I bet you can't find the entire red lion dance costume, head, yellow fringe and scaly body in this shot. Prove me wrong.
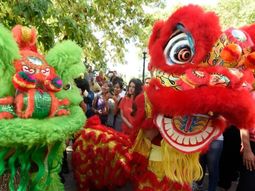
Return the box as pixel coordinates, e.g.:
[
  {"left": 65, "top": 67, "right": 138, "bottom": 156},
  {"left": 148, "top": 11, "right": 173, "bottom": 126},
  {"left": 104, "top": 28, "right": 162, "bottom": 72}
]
[{"left": 73, "top": 5, "right": 255, "bottom": 191}]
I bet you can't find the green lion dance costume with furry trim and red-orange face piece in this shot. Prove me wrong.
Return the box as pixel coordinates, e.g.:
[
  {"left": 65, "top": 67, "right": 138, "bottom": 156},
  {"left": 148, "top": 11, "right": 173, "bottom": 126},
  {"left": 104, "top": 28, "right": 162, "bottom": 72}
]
[{"left": 0, "top": 25, "right": 85, "bottom": 191}]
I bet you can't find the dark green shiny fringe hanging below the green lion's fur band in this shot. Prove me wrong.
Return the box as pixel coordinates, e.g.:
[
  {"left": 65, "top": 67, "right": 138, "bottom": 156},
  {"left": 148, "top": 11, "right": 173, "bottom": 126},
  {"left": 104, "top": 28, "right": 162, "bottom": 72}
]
[{"left": 0, "top": 142, "right": 64, "bottom": 191}]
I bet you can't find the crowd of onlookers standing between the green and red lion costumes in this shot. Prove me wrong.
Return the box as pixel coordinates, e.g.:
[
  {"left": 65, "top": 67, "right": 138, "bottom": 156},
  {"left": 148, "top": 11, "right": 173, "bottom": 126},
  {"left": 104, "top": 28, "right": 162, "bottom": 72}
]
[{"left": 76, "top": 66, "right": 147, "bottom": 135}]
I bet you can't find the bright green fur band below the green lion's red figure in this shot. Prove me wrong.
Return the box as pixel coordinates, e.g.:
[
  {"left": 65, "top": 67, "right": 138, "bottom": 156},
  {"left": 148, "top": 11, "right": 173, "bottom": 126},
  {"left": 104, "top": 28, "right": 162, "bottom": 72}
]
[{"left": 0, "top": 106, "right": 86, "bottom": 147}]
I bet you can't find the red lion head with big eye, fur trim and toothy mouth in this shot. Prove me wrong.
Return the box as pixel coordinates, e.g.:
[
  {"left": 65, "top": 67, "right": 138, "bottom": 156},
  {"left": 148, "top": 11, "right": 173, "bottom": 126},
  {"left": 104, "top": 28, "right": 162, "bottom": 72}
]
[{"left": 145, "top": 5, "right": 255, "bottom": 153}]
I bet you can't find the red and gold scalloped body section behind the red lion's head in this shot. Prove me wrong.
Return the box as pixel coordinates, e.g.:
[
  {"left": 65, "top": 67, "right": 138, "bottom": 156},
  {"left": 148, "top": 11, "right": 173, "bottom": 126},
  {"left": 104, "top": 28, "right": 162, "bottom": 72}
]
[{"left": 72, "top": 121, "right": 131, "bottom": 190}]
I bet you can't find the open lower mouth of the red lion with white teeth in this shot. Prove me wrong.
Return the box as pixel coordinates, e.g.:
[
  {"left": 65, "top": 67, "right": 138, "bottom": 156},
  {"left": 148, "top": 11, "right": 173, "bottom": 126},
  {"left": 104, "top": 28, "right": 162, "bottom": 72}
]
[{"left": 155, "top": 115, "right": 221, "bottom": 153}]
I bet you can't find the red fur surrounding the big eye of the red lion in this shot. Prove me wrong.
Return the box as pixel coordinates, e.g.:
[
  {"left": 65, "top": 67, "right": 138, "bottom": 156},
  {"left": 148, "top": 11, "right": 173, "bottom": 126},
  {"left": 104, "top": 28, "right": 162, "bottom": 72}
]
[{"left": 149, "top": 5, "right": 222, "bottom": 73}]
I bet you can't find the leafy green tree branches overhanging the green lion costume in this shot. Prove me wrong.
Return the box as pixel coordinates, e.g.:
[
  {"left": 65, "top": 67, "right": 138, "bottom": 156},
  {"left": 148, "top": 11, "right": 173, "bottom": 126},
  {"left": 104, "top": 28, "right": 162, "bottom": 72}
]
[{"left": 0, "top": 0, "right": 159, "bottom": 67}]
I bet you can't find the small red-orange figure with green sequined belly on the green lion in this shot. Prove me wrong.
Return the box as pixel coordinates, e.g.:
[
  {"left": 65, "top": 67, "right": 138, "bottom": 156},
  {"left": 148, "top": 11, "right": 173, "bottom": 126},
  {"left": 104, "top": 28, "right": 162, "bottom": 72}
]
[{"left": 0, "top": 25, "right": 69, "bottom": 119}]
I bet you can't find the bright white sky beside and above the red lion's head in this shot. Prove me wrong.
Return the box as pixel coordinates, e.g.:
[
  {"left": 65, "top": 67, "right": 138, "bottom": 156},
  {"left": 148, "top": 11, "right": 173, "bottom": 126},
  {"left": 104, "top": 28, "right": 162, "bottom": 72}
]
[{"left": 108, "top": 0, "right": 219, "bottom": 82}]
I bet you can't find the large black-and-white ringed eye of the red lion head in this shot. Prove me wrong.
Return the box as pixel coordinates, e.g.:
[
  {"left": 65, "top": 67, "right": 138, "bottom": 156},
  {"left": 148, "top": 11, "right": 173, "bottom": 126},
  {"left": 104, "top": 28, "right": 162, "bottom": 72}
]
[{"left": 164, "top": 31, "right": 194, "bottom": 65}]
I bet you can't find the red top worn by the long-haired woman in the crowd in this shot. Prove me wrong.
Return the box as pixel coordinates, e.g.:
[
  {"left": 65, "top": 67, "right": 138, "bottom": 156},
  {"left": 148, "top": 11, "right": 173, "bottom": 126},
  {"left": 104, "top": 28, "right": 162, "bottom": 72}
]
[{"left": 119, "top": 96, "right": 135, "bottom": 135}]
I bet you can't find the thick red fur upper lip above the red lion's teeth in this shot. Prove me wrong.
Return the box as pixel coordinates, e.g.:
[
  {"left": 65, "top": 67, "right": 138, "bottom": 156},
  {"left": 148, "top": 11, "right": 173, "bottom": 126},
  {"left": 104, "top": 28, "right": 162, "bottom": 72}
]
[{"left": 146, "top": 79, "right": 255, "bottom": 128}]
